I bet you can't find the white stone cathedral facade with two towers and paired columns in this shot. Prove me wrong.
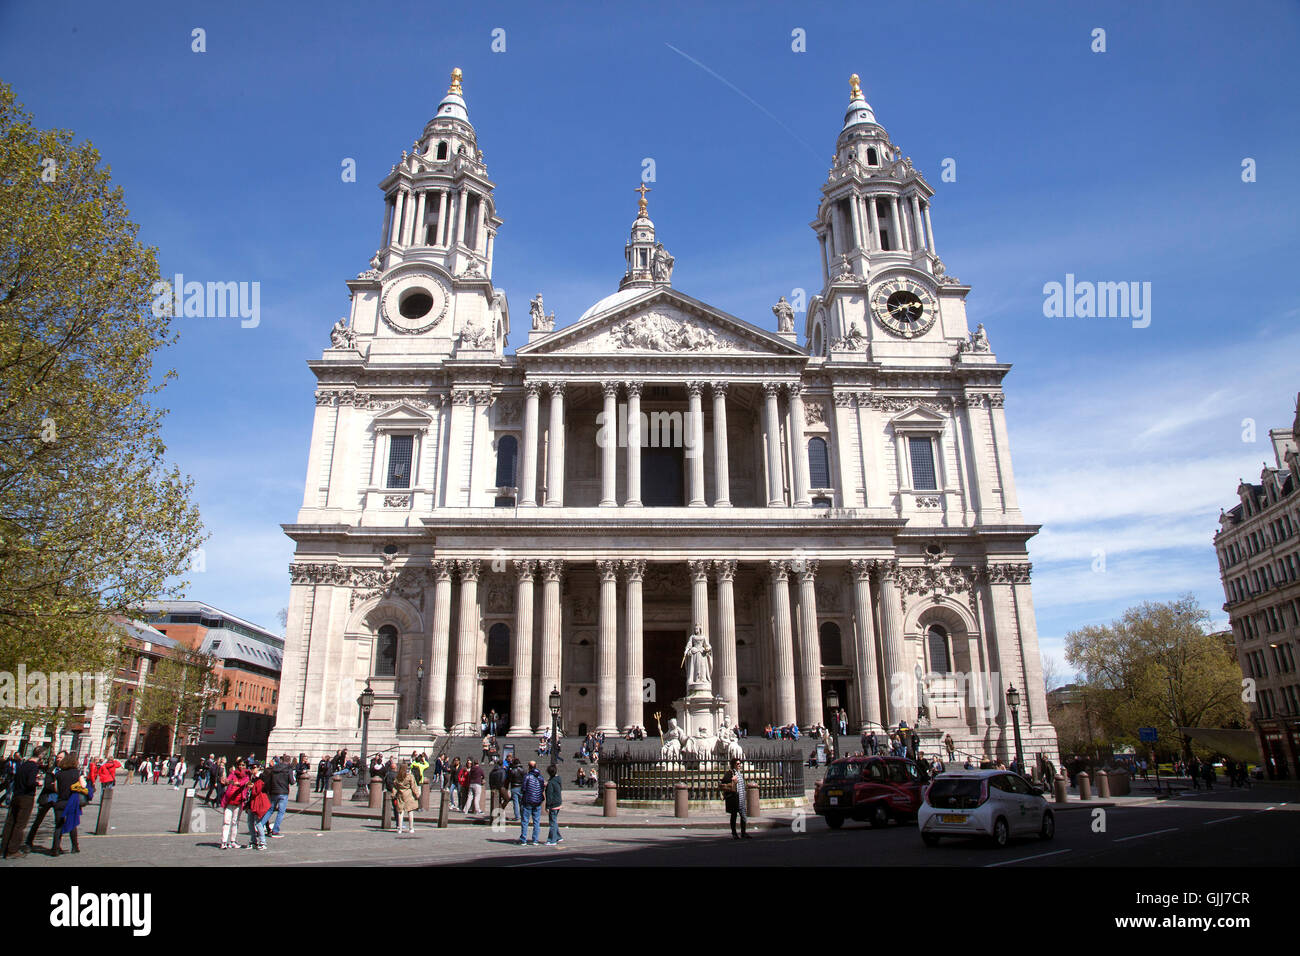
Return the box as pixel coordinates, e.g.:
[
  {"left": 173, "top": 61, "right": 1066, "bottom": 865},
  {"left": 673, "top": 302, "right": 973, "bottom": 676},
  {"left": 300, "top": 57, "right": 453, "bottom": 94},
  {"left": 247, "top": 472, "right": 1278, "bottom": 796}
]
[{"left": 270, "top": 70, "right": 1057, "bottom": 760}]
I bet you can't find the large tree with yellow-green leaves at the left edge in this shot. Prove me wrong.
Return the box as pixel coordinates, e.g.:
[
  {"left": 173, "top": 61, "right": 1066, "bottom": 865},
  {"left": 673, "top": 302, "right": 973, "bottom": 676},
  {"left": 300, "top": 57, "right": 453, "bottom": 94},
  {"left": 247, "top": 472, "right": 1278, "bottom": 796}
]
[{"left": 0, "top": 83, "right": 203, "bottom": 726}]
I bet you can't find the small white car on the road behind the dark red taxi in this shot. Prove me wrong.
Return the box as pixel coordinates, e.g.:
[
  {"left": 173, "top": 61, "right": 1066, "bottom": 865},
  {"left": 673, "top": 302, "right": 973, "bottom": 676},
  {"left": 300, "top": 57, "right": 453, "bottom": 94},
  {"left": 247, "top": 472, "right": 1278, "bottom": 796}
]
[{"left": 917, "top": 770, "right": 1056, "bottom": 847}]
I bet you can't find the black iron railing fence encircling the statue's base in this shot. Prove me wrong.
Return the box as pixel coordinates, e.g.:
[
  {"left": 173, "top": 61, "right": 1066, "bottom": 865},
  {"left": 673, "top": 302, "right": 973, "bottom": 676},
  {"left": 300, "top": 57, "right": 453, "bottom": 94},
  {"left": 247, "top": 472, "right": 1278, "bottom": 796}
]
[{"left": 599, "top": 749, "right": 805, "bottom": 801}]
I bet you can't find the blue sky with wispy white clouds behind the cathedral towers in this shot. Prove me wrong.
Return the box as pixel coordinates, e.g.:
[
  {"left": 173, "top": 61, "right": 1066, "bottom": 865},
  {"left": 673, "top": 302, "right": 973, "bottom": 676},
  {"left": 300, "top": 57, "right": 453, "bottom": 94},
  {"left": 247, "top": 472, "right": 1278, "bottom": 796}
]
[{"left": 0, "top": 0, "right": 1300, "bottom": 676}]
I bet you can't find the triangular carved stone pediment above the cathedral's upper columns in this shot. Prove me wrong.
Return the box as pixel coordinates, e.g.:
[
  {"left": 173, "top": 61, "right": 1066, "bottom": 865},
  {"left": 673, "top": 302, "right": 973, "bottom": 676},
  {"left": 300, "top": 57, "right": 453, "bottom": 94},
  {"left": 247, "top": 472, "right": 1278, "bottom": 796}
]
[{"left": 516, "top": 287, "right": 807, "bottom": 356}]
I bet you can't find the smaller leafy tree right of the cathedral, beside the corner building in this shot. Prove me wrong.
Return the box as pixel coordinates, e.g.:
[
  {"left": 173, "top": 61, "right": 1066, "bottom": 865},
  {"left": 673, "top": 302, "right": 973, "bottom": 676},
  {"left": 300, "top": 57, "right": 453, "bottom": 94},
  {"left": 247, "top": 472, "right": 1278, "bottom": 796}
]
[{"left": 1065, "top": 594, "right": 1249, "bottom": 757}]
